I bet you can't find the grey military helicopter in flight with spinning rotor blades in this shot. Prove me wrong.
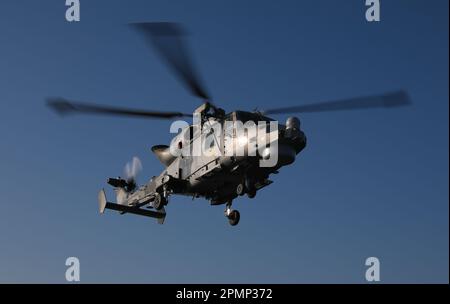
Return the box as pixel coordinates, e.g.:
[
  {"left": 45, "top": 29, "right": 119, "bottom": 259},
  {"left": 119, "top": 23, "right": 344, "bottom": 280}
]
[{"left": 47, "top": 22, "right": 410, "bottom": 226}]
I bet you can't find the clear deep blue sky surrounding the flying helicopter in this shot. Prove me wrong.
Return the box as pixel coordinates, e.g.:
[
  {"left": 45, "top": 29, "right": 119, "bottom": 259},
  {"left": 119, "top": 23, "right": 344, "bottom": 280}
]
[{"left": 0, "top": 0, "right": 449, "bottom": 283}]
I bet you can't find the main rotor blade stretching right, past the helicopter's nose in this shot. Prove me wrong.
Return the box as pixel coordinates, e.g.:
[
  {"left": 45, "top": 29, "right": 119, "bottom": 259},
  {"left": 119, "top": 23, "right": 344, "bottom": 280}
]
[{"left": 262, "top": 91, "right": 411, "bottom": 114}]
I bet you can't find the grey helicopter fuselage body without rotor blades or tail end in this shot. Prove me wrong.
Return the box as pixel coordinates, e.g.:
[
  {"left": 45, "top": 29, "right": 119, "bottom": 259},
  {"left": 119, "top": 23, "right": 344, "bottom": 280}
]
[{"left": 137, "top": 107, "right": 306, "bottom": 205}]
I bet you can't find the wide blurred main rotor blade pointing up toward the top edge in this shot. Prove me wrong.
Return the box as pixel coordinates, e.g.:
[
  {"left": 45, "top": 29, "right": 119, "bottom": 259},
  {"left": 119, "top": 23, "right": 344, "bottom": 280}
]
[{"left": 130, "top": 22, "right": 211, "bottom": 100}]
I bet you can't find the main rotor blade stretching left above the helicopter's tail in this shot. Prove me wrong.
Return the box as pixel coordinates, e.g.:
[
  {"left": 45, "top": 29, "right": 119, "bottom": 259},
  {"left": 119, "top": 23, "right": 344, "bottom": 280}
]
[{"left": 47, "top": 97, "right": 191, "bottom": 119}]
